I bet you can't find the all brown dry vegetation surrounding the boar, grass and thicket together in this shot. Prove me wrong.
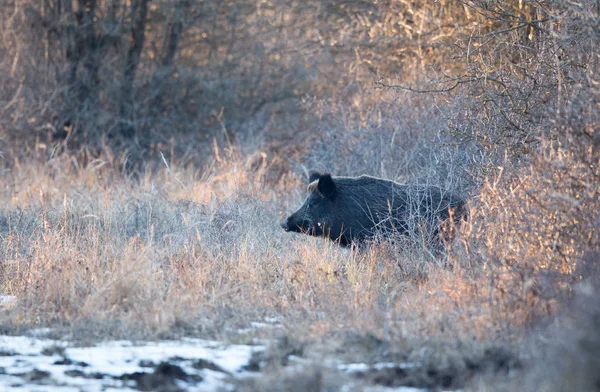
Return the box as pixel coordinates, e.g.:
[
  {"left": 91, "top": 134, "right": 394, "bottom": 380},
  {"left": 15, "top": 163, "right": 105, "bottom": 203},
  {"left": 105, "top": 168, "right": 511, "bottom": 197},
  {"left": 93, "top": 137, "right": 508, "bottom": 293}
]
[{"left": 0, "top": 0, "right": 600, "bottom": 390}]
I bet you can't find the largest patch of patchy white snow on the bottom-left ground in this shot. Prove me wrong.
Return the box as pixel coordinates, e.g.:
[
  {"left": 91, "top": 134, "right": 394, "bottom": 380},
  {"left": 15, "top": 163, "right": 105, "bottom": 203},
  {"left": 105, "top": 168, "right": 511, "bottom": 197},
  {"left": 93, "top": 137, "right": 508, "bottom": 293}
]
[{"left": 0, "top": 335, "right": 264, "bottom": 391}]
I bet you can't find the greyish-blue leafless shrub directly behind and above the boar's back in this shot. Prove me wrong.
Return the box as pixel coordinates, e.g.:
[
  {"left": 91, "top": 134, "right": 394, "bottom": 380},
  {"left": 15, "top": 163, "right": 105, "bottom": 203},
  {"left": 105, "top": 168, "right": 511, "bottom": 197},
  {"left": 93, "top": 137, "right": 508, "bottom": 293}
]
[{"left": 301, "top": 95, "right": 474, "bottom": 194}]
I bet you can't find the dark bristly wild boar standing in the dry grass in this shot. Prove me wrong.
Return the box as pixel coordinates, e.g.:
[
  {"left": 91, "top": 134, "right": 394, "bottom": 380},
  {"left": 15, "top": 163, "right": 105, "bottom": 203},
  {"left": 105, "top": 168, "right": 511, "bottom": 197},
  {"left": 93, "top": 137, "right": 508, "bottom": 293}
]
[{"left": 281, "top": 173, "right": 466, "bottom": 246}]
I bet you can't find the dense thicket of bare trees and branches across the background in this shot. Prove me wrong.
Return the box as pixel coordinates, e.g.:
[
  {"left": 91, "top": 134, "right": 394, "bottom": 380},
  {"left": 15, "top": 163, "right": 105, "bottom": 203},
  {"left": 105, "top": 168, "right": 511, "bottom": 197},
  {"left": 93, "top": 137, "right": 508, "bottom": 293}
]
[{"left": 0, "top": 0, "right": 598, "bottom": 155}]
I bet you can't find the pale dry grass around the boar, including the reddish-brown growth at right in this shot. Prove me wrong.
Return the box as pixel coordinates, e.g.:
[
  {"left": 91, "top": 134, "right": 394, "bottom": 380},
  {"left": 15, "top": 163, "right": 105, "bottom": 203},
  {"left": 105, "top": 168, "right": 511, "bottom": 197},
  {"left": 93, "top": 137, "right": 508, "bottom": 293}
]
[{"left": 0, "top": 121, "right": 598, "bottom": 389}]
